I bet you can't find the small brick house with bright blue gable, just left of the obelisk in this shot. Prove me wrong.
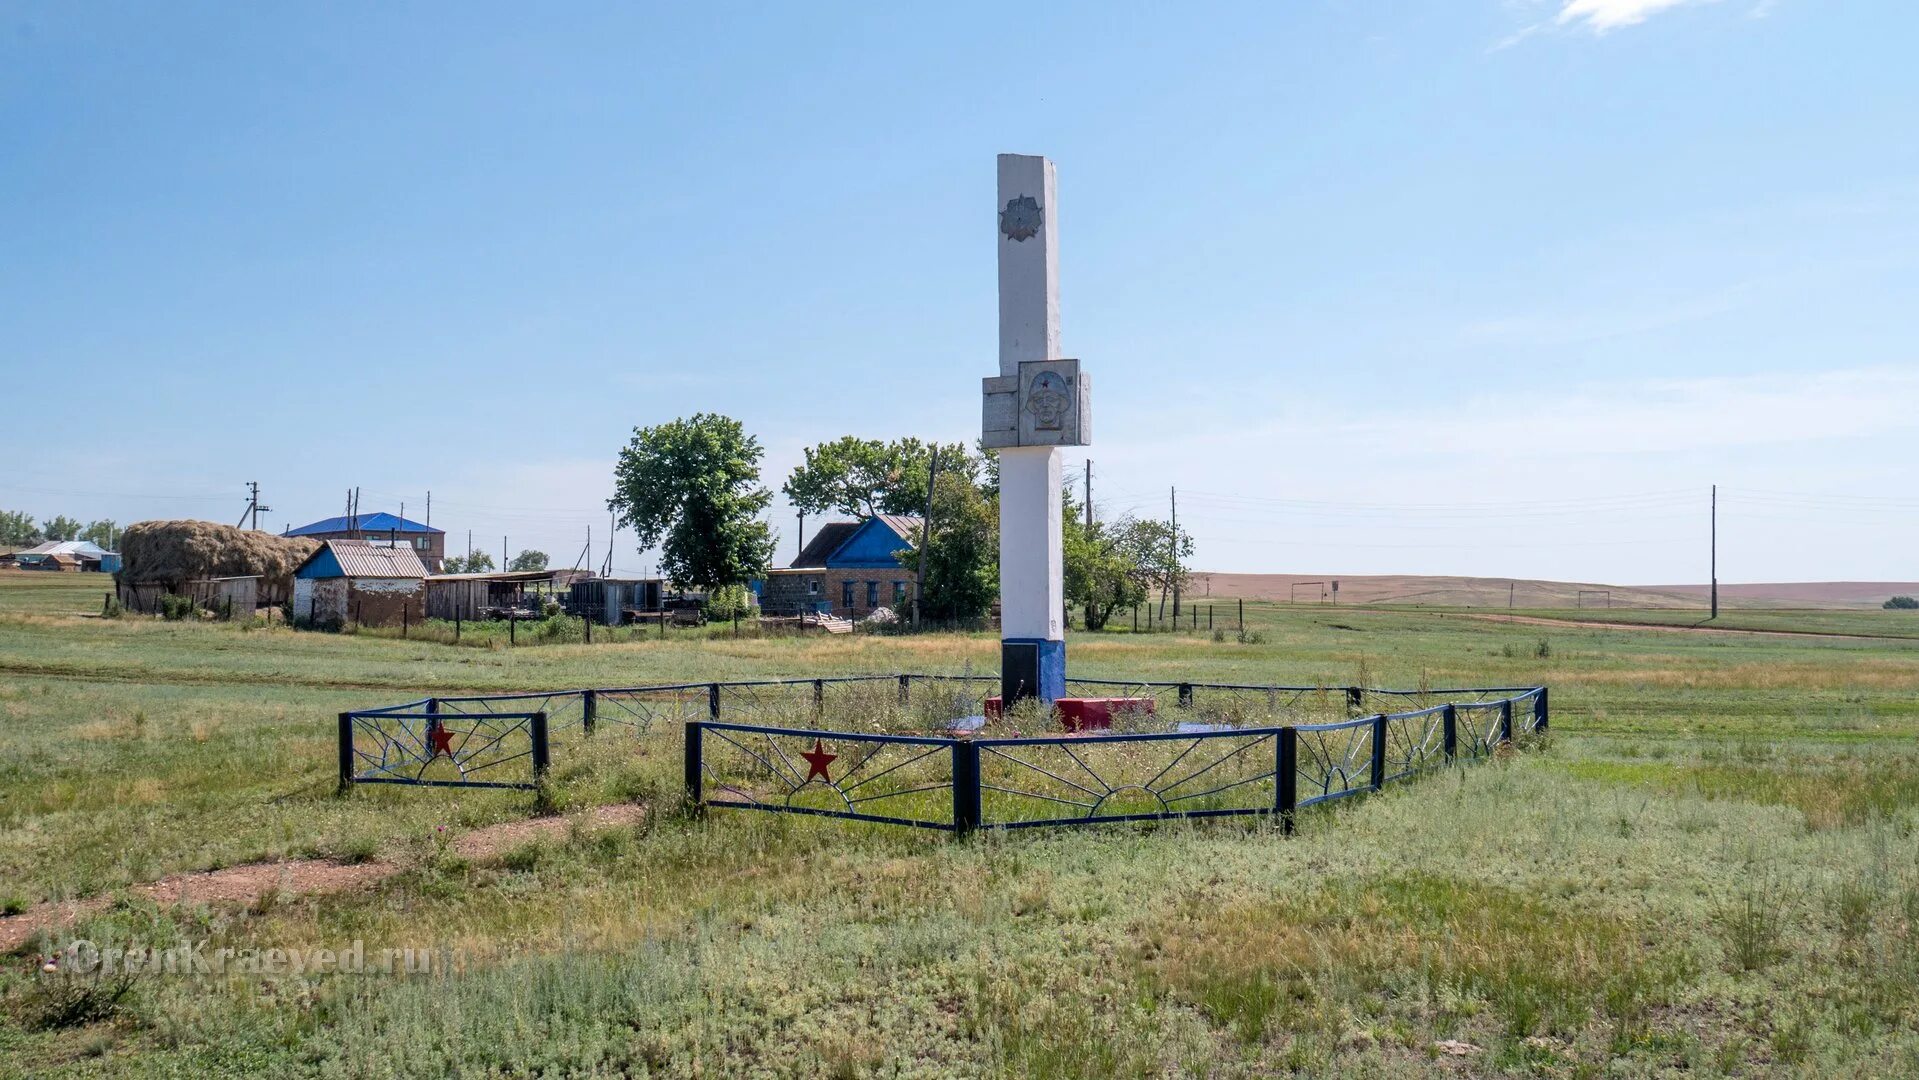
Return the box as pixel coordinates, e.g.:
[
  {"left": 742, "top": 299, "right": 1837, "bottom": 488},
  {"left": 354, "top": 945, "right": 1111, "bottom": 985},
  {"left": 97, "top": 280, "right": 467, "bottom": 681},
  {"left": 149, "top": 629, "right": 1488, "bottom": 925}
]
[{"left": 754, "top": 514, "right": 919, "bottom": 620}]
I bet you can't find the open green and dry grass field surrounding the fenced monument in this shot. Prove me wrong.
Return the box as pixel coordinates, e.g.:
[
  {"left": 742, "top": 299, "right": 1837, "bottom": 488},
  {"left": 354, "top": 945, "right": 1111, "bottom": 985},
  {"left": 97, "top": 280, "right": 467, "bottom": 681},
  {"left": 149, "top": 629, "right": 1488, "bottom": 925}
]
[{"left": 0, "top": 574, "right": 1919, "bottom": 1076}]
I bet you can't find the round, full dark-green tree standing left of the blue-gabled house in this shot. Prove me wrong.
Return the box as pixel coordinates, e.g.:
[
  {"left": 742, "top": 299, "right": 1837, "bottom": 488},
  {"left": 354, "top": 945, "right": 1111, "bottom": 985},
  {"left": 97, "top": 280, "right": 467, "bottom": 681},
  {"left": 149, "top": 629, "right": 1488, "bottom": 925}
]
[{"left": 606, "top": 412, "right": 773, "bottom": 589}]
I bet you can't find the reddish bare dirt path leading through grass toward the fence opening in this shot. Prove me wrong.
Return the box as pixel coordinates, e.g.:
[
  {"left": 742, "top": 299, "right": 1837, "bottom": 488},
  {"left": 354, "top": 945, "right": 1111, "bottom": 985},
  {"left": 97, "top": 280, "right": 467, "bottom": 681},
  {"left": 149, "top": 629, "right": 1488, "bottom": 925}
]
[{"left": 0, "top": 804, "right": 647, "bottom": 955}]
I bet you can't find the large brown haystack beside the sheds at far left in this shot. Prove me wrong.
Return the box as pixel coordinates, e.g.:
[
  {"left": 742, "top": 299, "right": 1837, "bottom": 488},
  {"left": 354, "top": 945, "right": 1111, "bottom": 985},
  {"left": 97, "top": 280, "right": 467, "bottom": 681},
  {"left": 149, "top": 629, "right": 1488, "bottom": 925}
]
[{"left": 119, "top": 522, "right": 320, "bottom": 597}]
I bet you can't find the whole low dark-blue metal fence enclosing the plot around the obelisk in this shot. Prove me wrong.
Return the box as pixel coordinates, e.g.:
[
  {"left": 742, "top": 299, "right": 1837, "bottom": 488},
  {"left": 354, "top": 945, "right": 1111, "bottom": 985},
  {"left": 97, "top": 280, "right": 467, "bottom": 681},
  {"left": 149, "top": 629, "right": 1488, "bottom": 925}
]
[{"left": 340, "top": 673, "right": 1549, "bottom": 833}]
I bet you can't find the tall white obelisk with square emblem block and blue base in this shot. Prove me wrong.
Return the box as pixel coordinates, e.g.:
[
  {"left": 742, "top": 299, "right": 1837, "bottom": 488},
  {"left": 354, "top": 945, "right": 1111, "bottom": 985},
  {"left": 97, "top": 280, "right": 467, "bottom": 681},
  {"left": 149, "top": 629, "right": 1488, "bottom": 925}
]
[{"left": 983, "top": 153, "right": 1092, "bottom": 704}]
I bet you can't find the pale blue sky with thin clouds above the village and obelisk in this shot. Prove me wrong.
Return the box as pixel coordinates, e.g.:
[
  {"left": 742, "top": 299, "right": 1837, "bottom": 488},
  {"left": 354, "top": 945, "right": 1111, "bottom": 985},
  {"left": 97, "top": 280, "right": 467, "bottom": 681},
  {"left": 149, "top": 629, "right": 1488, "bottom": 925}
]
[{"left": 0, "top": 0, "right": 1919, "bottom": 583}]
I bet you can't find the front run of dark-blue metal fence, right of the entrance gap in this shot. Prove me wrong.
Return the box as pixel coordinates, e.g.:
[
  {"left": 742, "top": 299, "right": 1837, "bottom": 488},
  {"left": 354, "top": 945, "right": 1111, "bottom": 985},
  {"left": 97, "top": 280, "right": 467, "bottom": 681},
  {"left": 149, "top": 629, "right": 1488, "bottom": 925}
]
[{"left": 683, "top": 683, "right": 1549, "bottom": 833}]
